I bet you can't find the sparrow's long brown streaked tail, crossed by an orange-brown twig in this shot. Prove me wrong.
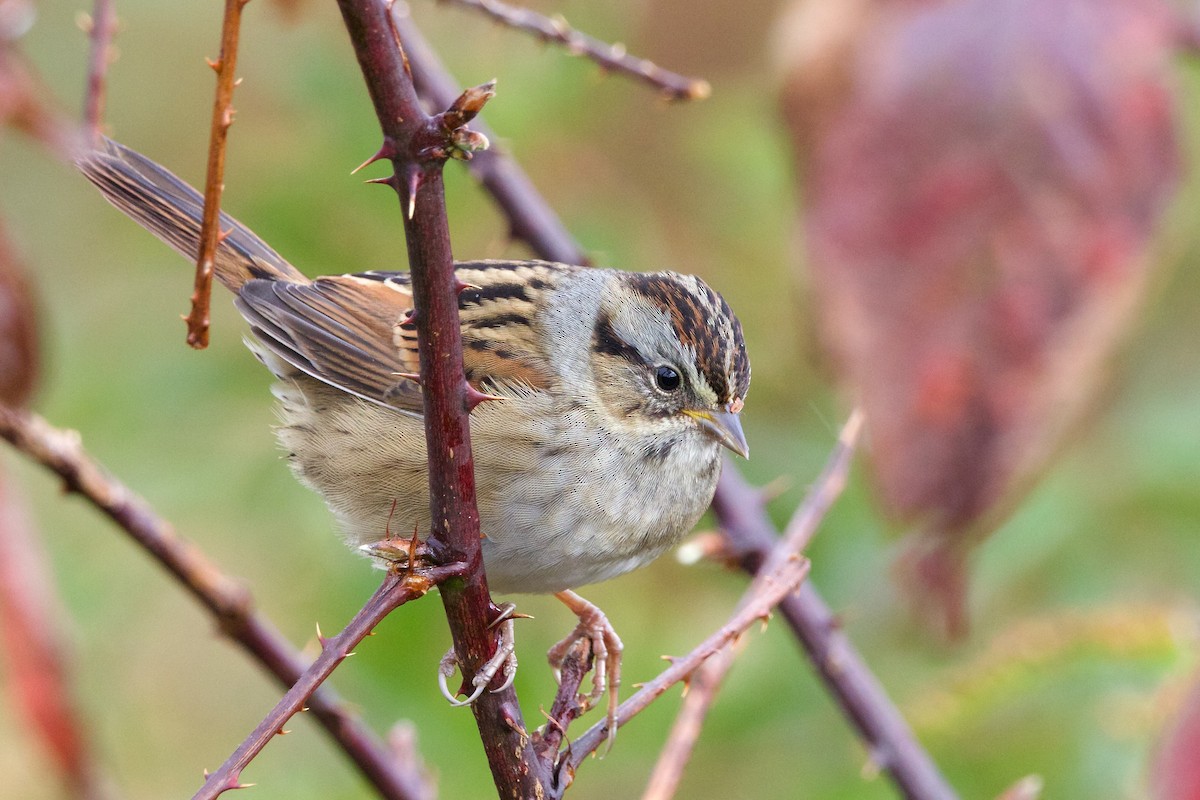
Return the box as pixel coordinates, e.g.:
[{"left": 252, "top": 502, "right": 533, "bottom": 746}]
[{"left": 76, "top": 139, "right": 308, "bottom": 291}]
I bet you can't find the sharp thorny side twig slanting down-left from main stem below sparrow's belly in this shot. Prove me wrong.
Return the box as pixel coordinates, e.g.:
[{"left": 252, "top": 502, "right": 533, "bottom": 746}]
[{"left": 192, "top": 564, "right": 466, "bottom": 800}]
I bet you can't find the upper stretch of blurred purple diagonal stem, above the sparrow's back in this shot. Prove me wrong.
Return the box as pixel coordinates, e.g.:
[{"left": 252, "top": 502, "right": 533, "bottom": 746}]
[{"left": 391, "top": 4, "right": 590, "bottom": 265}]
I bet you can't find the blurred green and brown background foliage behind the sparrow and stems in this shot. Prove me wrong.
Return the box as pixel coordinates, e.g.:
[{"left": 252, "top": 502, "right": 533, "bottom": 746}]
[{"left": 0, "top": 0, "right": 1200, "bottom": 800}]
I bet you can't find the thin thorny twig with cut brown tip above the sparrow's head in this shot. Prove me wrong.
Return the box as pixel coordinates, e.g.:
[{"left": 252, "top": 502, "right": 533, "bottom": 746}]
[{"left": 438, "top": 0, "right": 713, "bottom": 101}]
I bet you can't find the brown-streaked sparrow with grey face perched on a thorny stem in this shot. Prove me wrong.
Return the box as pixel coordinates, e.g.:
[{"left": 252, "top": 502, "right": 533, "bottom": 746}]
[{"left": 77, "top": 139, "right": 750, "bottom": 736}]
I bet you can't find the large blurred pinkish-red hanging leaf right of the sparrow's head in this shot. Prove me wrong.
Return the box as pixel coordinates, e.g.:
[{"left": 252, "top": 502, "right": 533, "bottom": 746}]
[{"left": 784, "top": 0, "right": 1183, "bottom": 636}]
